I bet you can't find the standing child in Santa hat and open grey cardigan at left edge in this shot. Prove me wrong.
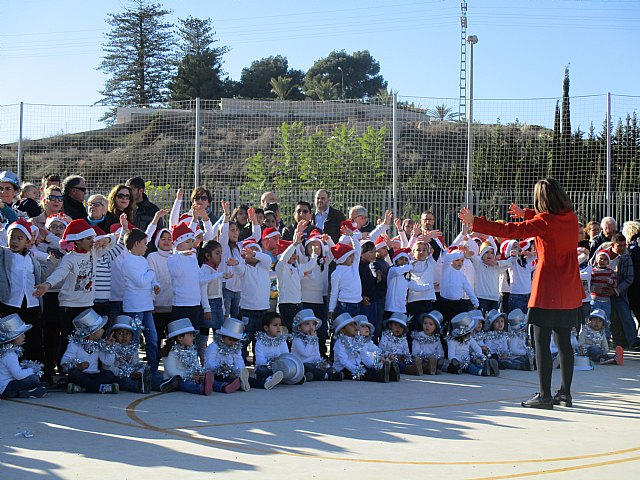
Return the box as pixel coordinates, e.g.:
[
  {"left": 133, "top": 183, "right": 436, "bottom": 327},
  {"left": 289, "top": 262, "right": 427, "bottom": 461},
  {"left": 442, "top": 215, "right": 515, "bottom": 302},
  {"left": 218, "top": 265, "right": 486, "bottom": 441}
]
[{"left": 0, "top": 218, "right": 44, "bottom": 361}]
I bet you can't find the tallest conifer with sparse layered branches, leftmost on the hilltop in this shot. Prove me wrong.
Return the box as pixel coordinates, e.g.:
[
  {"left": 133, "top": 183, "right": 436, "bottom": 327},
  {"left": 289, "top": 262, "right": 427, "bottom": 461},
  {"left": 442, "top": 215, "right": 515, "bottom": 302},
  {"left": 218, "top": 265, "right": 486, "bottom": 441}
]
[{"left": 98, "top": 0, "right": 173, "bottom": 118}]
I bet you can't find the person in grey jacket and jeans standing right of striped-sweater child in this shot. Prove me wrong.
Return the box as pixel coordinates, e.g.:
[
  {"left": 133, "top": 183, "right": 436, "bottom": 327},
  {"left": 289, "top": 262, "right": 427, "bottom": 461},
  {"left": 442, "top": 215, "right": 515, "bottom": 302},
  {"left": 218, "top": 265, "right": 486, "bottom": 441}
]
[{"left": 603, "top": 233, "right": 640, "bottom": 350}]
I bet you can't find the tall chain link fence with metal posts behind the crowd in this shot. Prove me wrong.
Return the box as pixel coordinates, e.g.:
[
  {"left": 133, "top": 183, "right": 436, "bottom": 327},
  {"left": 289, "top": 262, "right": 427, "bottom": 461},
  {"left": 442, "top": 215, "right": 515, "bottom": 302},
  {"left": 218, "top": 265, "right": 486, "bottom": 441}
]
[{"left": 0, "top": 94, "right": 640, "bottom": 244}]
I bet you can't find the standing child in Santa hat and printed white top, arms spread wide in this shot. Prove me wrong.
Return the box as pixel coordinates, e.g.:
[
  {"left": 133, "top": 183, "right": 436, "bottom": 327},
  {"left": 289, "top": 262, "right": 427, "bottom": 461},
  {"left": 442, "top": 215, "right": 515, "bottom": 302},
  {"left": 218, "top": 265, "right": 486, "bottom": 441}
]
[{"left": 34, "top": 217, "right": 116, "bottom": 364}]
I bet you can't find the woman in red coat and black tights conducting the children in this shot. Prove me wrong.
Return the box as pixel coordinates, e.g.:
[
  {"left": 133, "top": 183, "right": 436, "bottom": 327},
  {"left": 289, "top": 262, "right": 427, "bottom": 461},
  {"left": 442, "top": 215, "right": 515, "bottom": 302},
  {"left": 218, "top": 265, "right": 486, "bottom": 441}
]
[{"left": 458, "top": 178, "right": 584, "bottom": 410}]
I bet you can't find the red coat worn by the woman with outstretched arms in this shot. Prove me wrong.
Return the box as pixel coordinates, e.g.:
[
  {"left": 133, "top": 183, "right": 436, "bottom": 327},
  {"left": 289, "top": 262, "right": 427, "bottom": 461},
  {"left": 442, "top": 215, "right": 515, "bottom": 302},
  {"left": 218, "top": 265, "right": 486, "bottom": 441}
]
[{"left": 472, "top": 209, "right": 584, "bottom": 310}]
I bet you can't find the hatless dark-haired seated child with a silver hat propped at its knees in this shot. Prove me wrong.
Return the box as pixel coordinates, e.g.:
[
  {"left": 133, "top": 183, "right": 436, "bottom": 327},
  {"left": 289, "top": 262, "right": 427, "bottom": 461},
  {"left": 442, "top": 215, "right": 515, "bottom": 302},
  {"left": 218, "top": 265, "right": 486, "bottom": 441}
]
[{"left": 254, "top": 312, "right": 288, "bottom": 390}]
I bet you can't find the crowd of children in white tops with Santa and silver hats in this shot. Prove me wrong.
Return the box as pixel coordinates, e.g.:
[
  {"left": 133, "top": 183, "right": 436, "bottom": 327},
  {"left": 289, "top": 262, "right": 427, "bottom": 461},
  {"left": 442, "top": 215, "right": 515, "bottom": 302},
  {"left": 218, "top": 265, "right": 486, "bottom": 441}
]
[{"left": 0, "top": 172, "right": 623, "bottom": 398}]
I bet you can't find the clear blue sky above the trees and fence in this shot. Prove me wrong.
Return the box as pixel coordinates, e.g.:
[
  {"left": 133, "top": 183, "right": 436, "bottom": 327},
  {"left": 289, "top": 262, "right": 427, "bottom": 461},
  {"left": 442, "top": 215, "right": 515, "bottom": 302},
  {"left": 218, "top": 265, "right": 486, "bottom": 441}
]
[{"left": 0, "top": 0, "right": 640, "bottom": 130}]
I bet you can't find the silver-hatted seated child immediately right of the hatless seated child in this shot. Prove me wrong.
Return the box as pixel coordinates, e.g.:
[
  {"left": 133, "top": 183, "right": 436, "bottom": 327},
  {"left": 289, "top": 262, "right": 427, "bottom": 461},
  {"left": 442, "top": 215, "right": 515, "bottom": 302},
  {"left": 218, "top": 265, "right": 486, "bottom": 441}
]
[{"left": 291, "top": 309, "right": 344, "bottom": 381}]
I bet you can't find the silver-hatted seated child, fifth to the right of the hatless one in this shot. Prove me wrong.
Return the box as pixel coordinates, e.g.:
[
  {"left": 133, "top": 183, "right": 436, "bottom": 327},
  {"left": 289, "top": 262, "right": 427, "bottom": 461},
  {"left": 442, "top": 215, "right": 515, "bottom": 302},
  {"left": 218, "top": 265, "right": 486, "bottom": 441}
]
[{"left": 411, "top": 310, "right": 449, "bottom": 375}]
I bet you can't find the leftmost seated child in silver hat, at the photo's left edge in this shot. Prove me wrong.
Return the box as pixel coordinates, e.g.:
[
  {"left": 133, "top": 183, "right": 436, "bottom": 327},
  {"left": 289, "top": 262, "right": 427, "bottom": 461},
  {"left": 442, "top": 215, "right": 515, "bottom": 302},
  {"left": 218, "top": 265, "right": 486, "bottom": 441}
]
[{"left": 0, "top": 313, "right": 47, "bottom": 398}]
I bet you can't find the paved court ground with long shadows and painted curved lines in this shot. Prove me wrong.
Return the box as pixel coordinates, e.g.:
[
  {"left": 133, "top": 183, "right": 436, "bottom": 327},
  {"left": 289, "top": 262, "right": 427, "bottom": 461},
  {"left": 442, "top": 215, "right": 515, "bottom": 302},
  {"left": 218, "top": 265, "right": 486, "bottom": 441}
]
[{"left": 0, "top": 356, "right": 640, "bottom": 480}]
